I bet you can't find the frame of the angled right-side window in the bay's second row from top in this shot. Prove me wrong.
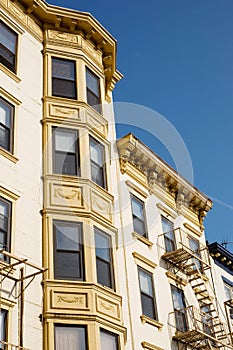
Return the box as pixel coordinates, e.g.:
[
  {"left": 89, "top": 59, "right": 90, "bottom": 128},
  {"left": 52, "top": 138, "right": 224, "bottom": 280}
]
[{"left": 89, "top": 135, "right": 108, "bottom": 190}]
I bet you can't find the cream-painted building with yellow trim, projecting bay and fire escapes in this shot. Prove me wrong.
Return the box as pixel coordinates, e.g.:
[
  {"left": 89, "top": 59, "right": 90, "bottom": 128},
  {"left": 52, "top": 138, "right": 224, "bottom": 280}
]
[{"left": 0, "top": 0, "right": 233, "bottom": 350}]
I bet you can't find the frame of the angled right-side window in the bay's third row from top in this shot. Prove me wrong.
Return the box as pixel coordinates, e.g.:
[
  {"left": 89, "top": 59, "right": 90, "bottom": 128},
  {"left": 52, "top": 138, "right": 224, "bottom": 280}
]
[{"left": 94, "top": 226, "right": 115, "bottom": 291}]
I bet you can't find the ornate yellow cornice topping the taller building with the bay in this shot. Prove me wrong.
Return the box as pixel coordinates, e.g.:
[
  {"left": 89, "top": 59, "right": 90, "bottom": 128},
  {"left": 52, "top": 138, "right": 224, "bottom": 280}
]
[{"left": 12, "top": 0, "right": 123, "bottom": 92}]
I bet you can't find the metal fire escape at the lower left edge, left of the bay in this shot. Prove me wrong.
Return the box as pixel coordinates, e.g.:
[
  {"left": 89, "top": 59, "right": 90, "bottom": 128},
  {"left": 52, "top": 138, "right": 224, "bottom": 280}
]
[{"left": 0, "top": 249, "right": 44, "bottom": 350}]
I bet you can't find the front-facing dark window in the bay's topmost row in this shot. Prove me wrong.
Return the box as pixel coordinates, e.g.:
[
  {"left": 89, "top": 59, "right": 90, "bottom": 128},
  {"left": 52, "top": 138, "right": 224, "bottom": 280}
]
[{"left": 52, "top": 57, "right": 77, "bottom": 99}]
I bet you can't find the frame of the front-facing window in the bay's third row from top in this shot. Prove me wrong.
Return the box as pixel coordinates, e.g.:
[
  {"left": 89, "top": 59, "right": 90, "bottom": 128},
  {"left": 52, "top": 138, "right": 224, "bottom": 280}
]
[{"left": 53, "top": 219, "right": 85, "bottom": 281}]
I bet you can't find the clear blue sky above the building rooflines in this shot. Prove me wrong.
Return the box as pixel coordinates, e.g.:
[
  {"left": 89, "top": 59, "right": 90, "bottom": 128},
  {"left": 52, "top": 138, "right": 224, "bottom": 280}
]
[{"left": 49, "top": 0, "right": 233, "bottom": 251}]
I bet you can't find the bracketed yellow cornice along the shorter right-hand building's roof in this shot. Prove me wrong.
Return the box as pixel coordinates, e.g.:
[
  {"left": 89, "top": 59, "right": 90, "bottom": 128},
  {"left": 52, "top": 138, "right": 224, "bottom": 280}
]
[{"left": 117, "top": 134, "right": 212, "bottom": 231}]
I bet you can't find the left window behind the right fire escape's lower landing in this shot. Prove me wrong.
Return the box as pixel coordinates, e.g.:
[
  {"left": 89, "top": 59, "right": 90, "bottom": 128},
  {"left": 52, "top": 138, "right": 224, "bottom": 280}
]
[{"left": 171, "top": 286, "right": 188, "bottom": 332}]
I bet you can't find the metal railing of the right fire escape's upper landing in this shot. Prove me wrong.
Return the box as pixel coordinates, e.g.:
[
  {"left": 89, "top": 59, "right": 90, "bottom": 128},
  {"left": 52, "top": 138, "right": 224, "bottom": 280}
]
[{"left": 158, "top": 228, "right": 210, "bottom": 269}]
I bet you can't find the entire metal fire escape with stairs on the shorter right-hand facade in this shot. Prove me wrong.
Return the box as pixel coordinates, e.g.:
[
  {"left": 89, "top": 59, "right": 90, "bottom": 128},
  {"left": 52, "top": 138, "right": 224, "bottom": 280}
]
[{"left": 158, "top": 228, "right": 233, "bottom": 350}]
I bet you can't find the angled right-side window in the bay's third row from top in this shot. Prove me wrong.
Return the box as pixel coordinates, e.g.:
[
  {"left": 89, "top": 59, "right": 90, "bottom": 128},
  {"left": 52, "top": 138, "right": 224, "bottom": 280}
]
[{"left": 95, "top": 228, "right": 114, "bottom": 288}]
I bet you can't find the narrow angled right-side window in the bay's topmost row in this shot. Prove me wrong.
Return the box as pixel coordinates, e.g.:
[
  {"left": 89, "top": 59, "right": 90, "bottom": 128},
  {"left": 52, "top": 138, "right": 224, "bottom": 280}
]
[{"left": 86, "top": 68, "right": 101, "bottom": 113}]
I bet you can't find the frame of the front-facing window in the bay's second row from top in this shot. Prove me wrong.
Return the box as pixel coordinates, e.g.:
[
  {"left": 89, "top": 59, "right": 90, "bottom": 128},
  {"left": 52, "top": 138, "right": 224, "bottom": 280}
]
[{"left": 52, "top": 126, "right": 80, "bottom": 176}]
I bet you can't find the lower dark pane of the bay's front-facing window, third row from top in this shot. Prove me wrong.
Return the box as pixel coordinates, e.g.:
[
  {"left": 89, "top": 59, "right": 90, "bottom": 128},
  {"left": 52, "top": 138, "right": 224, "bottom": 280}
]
[{"left": 55, "top": 252, "right": 82, "bottom": 279}]
